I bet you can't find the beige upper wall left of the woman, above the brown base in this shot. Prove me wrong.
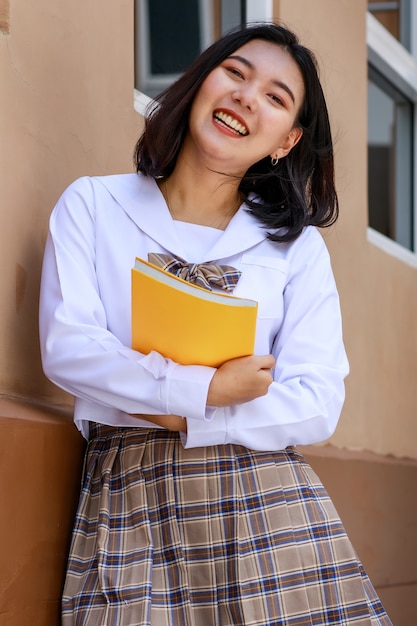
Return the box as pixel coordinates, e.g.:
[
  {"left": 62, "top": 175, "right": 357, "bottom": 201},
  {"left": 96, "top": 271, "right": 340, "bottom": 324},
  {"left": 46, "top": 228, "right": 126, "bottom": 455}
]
[{"left": 0, "top": 0, "right": 141, "bottom": 402}]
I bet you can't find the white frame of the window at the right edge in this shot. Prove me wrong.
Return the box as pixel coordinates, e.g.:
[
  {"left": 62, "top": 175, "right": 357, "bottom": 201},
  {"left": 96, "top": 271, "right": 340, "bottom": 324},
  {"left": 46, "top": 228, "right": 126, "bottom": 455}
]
[{"left": 366, "top": 10, "right": 417, "bottom": 267}]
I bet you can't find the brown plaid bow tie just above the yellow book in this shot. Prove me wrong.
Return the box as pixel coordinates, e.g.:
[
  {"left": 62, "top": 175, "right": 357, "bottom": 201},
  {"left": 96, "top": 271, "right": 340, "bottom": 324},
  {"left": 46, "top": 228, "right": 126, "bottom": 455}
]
[{"left": 148, "top": 252, "right": 242, "bottom": 291}]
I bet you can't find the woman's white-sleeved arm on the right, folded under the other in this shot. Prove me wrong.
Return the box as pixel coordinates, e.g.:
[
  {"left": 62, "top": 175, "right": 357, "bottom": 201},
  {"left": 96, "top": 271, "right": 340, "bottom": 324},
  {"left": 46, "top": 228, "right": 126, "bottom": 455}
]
[{"left": 183, "top": 229, "right": 349, "bottom": 450}]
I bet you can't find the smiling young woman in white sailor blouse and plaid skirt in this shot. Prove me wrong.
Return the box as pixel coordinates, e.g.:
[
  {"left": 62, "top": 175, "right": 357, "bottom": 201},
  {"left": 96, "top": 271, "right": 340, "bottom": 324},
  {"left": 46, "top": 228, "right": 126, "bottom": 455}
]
[{"left": 40, "top": 24, "right": 391, "bottom": 626}]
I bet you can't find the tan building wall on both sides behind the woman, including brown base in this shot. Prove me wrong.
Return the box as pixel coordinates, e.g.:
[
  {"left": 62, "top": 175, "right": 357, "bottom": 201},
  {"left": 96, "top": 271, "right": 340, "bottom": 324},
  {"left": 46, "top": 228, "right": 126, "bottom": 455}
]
[{"left": 0, "top": 0, "right": 417, "bottom": 626}]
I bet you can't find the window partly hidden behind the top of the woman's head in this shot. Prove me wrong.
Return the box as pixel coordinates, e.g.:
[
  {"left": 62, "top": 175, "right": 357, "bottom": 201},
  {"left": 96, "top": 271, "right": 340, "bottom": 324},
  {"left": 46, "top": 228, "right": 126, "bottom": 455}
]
[{"left": 135, "top": 0, "right": 273, "bottom": 113}]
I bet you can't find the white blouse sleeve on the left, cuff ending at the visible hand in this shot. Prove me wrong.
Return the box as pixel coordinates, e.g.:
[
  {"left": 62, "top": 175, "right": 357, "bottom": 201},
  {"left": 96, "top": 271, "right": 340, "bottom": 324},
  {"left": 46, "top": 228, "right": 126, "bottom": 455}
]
[{"left": 40, "top": 178, "right": 214, "bottom": 421}]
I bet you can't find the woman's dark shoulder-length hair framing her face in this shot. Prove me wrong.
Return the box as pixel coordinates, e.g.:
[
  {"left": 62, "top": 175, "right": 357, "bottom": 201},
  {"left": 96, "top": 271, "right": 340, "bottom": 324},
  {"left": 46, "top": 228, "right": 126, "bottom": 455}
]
[{"left": 134, "top": 24, "right": 339, "bottom": 241}]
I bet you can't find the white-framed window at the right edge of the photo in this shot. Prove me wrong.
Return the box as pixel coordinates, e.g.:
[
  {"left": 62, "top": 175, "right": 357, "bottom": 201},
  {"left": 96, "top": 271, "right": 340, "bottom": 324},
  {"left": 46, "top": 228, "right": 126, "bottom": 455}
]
[{"left": 367, "top": 7, "right": 417, "bottom": 256}]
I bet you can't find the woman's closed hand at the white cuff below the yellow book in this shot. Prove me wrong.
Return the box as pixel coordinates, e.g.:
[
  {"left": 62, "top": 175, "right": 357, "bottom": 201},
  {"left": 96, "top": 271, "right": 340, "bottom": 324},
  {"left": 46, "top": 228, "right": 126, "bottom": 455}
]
[{"left": 207, "top": 354, "right": 275, "bottom": 407}]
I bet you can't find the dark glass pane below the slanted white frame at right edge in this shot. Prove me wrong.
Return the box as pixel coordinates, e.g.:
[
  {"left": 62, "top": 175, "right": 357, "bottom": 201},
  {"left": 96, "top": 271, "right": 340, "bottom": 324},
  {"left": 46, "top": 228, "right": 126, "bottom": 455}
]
[{"left": 368, "top": 68, "right": 413, "bottom": 250}]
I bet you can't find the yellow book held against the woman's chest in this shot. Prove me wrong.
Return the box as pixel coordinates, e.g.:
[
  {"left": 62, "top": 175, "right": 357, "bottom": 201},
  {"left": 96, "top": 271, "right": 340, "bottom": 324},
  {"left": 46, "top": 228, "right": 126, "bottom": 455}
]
[{"left": 132, "top": 258, "right": 258, "bottom": 367}]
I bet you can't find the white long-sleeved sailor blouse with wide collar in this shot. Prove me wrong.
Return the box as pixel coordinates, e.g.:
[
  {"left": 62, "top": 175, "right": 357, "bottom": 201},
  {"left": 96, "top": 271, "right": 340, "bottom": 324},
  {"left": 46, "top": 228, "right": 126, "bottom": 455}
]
[{"left": 40, "top": 174, "right": 348, "bottom": 450}]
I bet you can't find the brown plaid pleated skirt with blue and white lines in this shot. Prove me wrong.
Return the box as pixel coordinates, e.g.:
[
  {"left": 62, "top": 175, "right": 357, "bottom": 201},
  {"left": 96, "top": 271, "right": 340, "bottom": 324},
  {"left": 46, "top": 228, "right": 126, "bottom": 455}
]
[{"left": 62, "top": 424, "right": 392, "bottom": 626}]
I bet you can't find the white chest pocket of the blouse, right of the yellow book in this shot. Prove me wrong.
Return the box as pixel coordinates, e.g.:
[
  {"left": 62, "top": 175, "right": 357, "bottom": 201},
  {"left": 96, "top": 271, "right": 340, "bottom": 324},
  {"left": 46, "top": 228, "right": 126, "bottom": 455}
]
[{"left": 235, "top": 254, "right": 289, "bottom": 322}]
